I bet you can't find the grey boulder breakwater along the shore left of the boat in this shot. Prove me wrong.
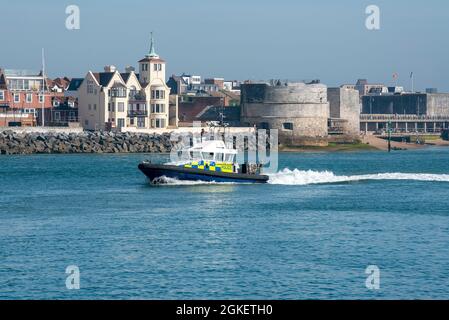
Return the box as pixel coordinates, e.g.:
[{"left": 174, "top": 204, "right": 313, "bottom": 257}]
[{"left": 0, "top": 130, "right": 172, "bottom": 154}]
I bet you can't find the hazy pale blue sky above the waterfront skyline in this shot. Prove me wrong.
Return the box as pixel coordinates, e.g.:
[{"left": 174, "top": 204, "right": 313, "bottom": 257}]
[{"left": 0, "top": 0, "right": 449, "bottom": 91}]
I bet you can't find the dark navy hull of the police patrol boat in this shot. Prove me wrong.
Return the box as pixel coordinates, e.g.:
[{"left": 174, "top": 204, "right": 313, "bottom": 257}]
[{"left": 139, "top": 163, "right": 269, "bottom": 183}]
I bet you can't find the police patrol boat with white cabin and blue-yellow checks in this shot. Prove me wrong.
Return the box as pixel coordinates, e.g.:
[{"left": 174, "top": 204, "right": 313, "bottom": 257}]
[{"left": 139, "top": 132, "right": 269, "bottom": 183}]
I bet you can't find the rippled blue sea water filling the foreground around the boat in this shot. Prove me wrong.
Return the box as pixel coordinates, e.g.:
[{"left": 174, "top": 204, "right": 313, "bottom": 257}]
[{"left": 0, "top": 148, "right": 449, "bottom": 299}]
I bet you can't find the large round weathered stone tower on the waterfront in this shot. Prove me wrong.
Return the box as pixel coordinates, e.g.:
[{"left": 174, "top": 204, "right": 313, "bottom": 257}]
[{"left": 241, "top": 83, "right": 329, "bottom": 145}]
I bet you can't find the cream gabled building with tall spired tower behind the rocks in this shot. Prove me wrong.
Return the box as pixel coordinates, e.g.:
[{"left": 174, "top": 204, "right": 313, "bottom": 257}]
[{"left": 77, "top": 37, "right": 170, "bottom": 130}]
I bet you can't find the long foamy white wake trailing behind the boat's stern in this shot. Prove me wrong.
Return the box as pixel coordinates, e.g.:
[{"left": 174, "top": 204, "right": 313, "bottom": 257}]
[{"left": 268, "top": 169, "right": 449, "bottom": 185}]
